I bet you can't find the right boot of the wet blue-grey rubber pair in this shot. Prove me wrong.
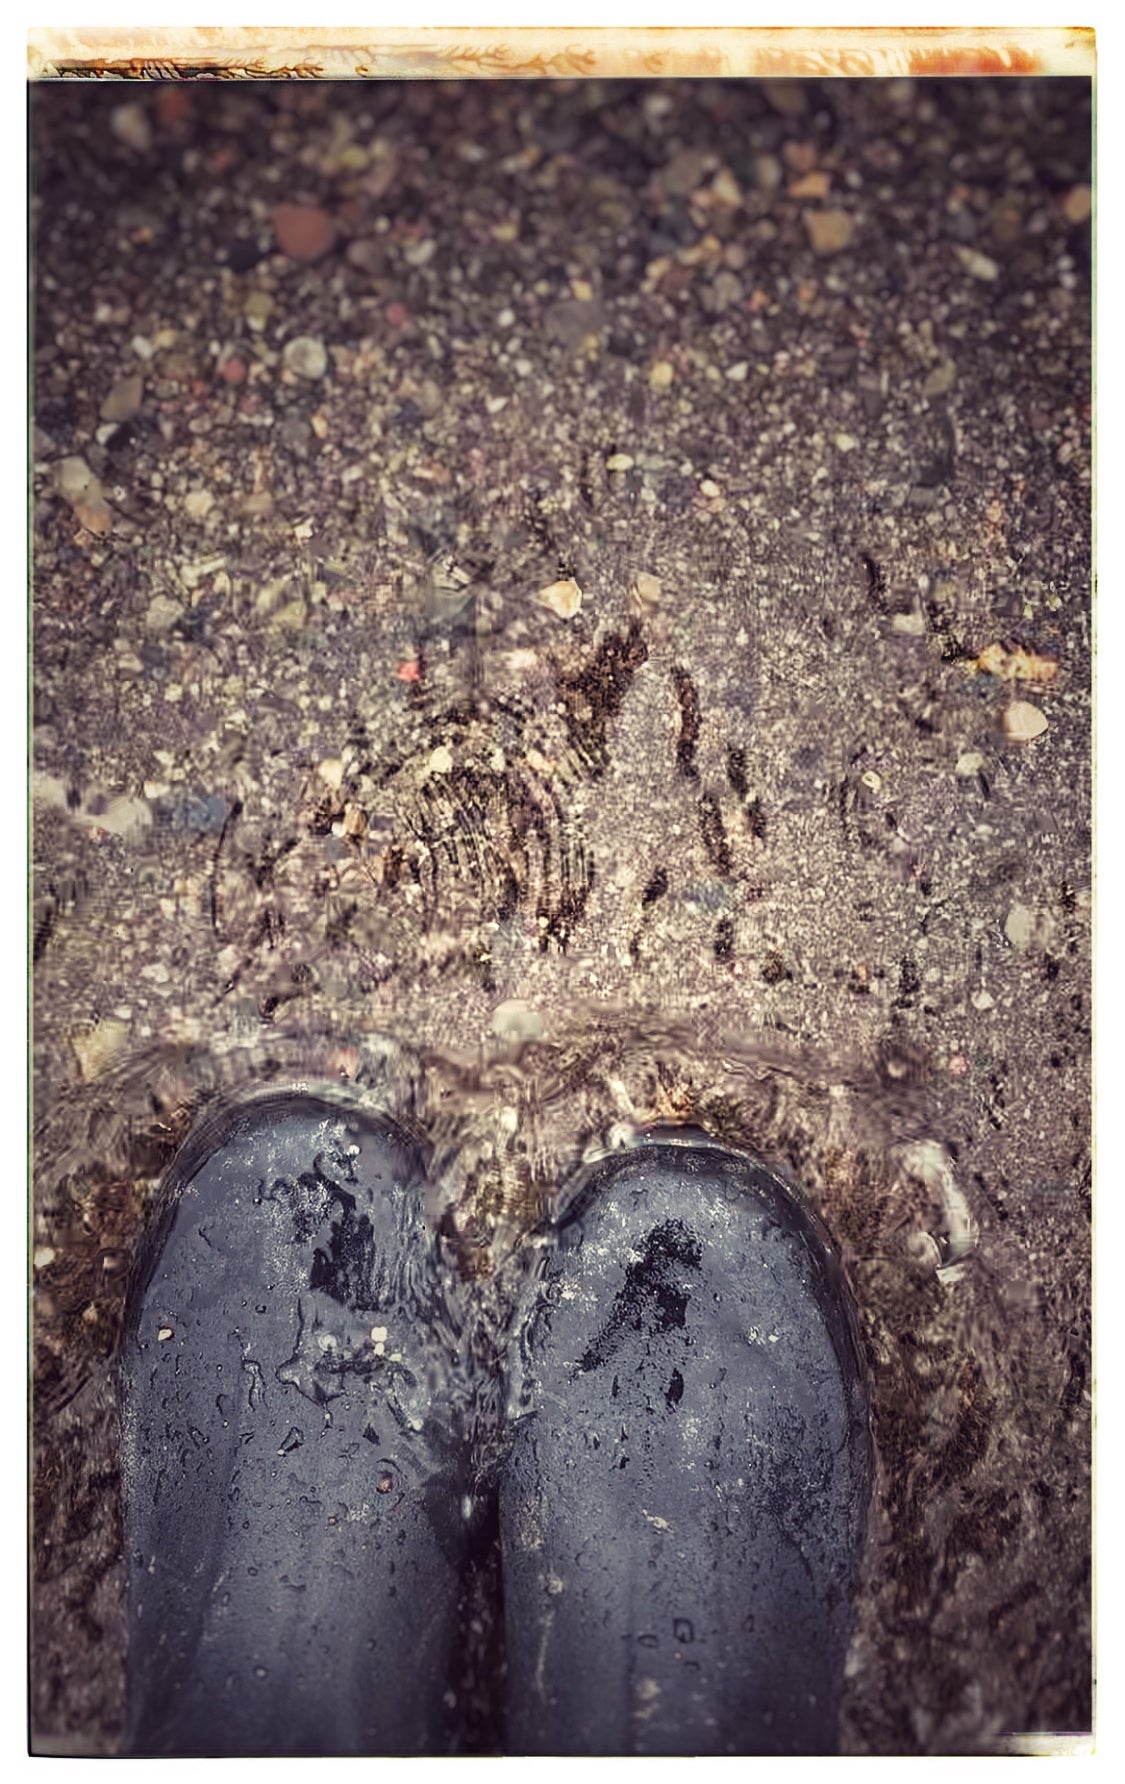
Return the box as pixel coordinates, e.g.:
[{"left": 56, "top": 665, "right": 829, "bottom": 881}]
[{"left": 501, "top": 1135, "right": 870, "bottom": 1755}]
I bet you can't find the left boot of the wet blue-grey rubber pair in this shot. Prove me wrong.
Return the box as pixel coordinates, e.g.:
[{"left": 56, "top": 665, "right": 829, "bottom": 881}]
[{"left": 123, "top": 1094, "right": 464, "bottom": 1755}]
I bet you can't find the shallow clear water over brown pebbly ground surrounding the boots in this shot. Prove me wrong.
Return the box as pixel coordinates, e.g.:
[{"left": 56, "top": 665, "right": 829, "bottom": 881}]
[{"left": 32, "top": 82, "right": 1089, "bottom": 1752}]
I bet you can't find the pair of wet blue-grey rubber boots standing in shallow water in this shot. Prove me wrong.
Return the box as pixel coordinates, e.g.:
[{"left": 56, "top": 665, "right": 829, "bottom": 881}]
[{"left": 121, "top": 1092, "right": 870, "bottom": 1755}]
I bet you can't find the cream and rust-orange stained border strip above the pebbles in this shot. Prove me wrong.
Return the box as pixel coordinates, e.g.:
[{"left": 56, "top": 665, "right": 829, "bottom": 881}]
[{"left": 27, "top": 25, "right": 1095, "bottom": 80}]
